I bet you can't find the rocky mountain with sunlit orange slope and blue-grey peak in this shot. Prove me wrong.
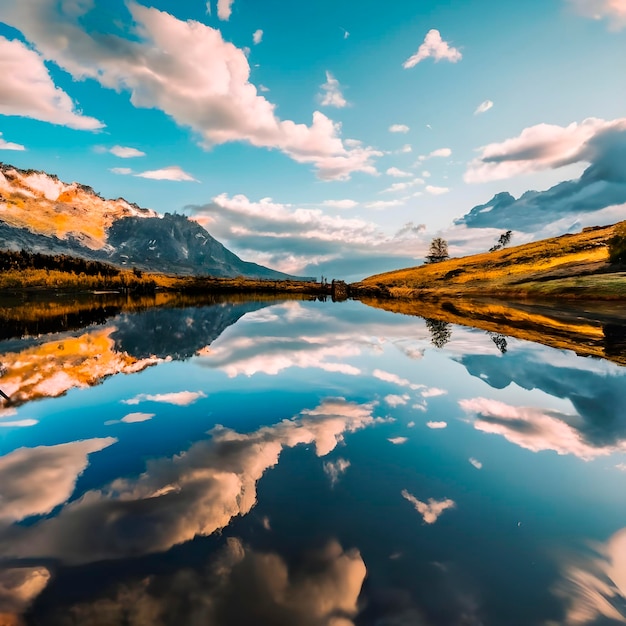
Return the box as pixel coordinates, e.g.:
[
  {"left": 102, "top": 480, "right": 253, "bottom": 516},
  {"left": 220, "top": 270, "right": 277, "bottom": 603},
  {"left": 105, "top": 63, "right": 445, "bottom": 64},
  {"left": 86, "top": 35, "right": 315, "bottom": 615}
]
[{"left": 0, "top": 163, "right": 297, "bottom": 280}]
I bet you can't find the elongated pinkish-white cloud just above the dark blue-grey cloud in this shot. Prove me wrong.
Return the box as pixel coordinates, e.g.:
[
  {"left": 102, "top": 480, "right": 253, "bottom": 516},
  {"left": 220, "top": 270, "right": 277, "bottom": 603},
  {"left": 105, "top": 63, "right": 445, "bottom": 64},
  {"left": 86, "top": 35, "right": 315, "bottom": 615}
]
[{"left": 463, "top": 117, "right": 626, "bottom": 183}]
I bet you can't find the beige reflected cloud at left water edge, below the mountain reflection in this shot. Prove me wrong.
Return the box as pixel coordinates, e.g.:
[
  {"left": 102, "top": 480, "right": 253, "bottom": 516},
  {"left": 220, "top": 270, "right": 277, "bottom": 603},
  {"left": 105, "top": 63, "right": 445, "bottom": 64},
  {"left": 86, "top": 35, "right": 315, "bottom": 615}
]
[{"left": 0, "top": 437, "right": 117, "bottom": 524}]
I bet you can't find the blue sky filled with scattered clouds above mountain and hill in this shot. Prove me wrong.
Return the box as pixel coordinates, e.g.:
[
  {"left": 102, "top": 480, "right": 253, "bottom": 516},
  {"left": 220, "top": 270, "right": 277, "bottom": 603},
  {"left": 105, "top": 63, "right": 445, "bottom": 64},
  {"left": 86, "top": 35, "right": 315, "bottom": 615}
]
[{"left": 0, "top": 0, "right": 626, "bottom": 279}]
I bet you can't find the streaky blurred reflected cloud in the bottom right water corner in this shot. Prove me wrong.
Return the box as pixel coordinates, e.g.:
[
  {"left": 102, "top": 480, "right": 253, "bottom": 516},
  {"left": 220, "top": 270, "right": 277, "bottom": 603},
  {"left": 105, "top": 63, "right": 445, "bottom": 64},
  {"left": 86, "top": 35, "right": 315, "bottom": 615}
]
[{"left": 554, "top": 528, "right": 626, "bottom": 626}]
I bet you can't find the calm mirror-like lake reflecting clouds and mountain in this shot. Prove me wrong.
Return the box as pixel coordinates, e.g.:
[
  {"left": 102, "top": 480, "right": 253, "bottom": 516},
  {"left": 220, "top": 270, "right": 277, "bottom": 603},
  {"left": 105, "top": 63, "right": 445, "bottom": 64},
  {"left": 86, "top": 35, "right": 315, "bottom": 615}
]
[{"left": 0, "top": 295, "right": 626, "bottom": 626}]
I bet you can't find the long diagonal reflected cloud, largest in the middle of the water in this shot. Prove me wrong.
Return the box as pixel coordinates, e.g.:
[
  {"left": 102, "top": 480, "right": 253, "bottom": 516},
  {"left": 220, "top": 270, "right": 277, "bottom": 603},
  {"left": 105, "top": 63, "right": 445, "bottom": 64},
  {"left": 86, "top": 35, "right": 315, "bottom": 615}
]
[{"left": 0, "top": 398, "right": 383, "bottom": 564}]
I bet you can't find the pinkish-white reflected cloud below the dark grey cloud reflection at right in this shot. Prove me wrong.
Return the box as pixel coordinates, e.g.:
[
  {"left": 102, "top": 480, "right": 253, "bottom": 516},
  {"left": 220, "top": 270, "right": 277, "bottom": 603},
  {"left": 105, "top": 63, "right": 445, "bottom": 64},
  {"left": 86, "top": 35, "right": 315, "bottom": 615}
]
[{"left": 459, "top": 398, "right": 626, "bottom": 461}]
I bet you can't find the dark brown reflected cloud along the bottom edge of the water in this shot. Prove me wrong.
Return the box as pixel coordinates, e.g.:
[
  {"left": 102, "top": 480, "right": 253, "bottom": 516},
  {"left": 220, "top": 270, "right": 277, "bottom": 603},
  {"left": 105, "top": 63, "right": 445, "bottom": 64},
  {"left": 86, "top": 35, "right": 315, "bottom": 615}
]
[{"left": 29, "top": 537, "right": 367, "bottom": 626}]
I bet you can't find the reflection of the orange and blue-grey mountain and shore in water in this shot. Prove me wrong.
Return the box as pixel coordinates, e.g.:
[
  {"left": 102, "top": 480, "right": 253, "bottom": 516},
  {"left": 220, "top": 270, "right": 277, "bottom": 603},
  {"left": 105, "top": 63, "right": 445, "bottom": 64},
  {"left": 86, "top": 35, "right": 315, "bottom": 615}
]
[{"left": 0, "top": 294, "right": 273, "bottom": 405}]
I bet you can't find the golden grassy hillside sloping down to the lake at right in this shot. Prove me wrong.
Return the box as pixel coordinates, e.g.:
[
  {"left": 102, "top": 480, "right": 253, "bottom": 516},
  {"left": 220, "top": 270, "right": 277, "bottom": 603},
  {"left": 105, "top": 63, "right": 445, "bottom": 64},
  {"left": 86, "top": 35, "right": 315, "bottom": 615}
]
[{"left": 350, "top": 222, "right": 626, "bottom": 300}]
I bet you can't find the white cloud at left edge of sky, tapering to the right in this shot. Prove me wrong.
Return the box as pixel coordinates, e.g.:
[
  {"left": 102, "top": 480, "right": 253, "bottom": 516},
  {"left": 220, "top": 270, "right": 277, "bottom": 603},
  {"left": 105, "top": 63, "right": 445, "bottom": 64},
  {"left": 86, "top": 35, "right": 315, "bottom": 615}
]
[{"left": 0, "top": 37, "right": 104, "bottom": 130}]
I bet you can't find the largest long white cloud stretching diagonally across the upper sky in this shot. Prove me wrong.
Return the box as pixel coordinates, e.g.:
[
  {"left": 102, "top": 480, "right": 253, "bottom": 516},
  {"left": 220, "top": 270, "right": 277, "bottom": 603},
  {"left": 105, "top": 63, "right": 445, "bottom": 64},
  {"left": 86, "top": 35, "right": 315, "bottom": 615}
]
[{"left": 5, "top": 0, "right": 382, "bottom": 180}]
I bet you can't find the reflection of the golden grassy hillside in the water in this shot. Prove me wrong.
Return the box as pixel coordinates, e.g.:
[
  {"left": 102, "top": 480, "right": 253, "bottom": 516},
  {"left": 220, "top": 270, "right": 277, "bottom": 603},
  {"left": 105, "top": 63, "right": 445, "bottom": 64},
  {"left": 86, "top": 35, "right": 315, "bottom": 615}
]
[{"left": 362, "top": 298, "right": 626, "bottom": 365}]
